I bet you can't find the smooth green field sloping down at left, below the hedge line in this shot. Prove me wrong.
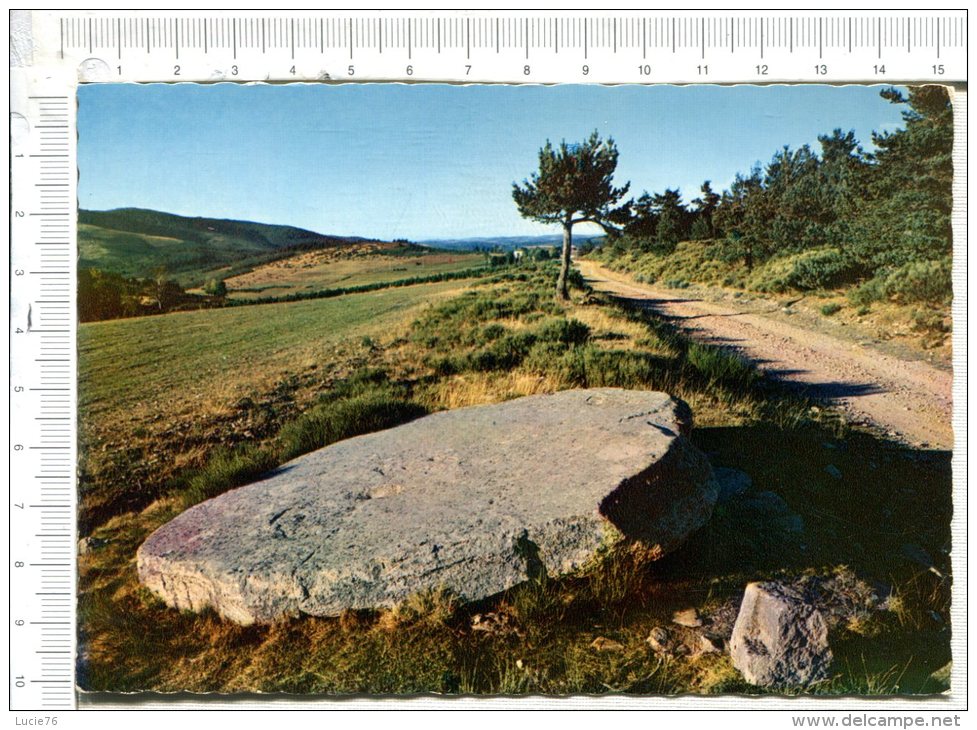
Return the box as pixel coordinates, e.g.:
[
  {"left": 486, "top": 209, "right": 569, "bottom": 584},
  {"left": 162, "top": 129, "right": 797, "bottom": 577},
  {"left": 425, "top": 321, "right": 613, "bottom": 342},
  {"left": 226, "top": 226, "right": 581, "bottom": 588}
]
[{"left": 78, "top": 281, "right": 480, "bottom": 526}]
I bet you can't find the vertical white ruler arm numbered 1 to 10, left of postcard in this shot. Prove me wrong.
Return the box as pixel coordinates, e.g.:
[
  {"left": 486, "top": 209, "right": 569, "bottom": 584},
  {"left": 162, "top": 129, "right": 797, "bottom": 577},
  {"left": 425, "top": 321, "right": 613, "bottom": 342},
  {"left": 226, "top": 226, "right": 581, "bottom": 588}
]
[{"left": 8, "top": 82, "right": 76, "bottom": 709}]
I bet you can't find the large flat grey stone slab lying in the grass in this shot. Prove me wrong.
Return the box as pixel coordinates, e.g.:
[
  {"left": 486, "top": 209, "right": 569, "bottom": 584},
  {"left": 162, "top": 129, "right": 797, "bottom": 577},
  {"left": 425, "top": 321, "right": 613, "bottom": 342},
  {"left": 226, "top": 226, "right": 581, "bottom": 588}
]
[{"left": 137, "top": 388, "right": 718, "bottom": 624}]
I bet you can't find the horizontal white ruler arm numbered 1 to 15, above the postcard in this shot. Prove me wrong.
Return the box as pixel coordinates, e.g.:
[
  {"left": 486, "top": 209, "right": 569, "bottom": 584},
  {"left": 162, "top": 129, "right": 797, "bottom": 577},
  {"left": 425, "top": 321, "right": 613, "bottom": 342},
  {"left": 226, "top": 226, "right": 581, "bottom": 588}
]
[{"left": 22, "top": 10, "right": 967, "bottom": 83}]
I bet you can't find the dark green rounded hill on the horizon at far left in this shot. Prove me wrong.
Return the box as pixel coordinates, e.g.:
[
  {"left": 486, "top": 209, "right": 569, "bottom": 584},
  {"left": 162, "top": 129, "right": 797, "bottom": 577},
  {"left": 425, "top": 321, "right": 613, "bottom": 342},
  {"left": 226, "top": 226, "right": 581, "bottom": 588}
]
[{"left": 78, "top": 208, "right": 372, "bottom": 286}]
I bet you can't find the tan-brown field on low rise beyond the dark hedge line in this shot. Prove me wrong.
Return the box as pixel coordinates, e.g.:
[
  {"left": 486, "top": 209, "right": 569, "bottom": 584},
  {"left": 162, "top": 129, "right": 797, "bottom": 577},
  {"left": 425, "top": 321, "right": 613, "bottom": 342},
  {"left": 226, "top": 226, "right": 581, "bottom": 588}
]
[{"left": 217, "top": 244, "right": 485, "bottom": 299}]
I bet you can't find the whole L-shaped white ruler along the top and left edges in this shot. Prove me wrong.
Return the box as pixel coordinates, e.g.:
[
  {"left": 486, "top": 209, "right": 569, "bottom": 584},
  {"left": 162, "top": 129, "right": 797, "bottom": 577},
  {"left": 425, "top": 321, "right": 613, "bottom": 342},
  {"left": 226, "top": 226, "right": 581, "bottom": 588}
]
[{"left": 8, "top": 10, "right": 967, "bottom": 710}]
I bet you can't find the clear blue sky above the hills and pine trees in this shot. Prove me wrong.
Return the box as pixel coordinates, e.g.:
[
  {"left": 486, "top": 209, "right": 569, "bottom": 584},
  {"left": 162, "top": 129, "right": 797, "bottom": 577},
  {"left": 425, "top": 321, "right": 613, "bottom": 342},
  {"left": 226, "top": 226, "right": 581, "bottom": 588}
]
[{"left": 78, "top": 84, "right": 901, "bottom": 240}]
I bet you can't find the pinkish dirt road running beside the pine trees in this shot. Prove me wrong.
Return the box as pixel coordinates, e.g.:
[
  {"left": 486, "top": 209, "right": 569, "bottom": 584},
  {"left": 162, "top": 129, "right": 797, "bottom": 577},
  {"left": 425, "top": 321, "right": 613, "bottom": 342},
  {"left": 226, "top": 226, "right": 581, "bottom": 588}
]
[{"left": 577, "top": 261, "right": 953, "bottom": 449}]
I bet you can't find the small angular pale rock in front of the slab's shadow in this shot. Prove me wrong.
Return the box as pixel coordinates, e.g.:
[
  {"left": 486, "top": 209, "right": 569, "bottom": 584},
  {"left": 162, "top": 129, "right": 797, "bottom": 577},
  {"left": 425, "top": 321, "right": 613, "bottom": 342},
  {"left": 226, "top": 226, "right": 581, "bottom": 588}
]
[{"left": 730, "top": 582, "right": 833, "bottom": 687}]
